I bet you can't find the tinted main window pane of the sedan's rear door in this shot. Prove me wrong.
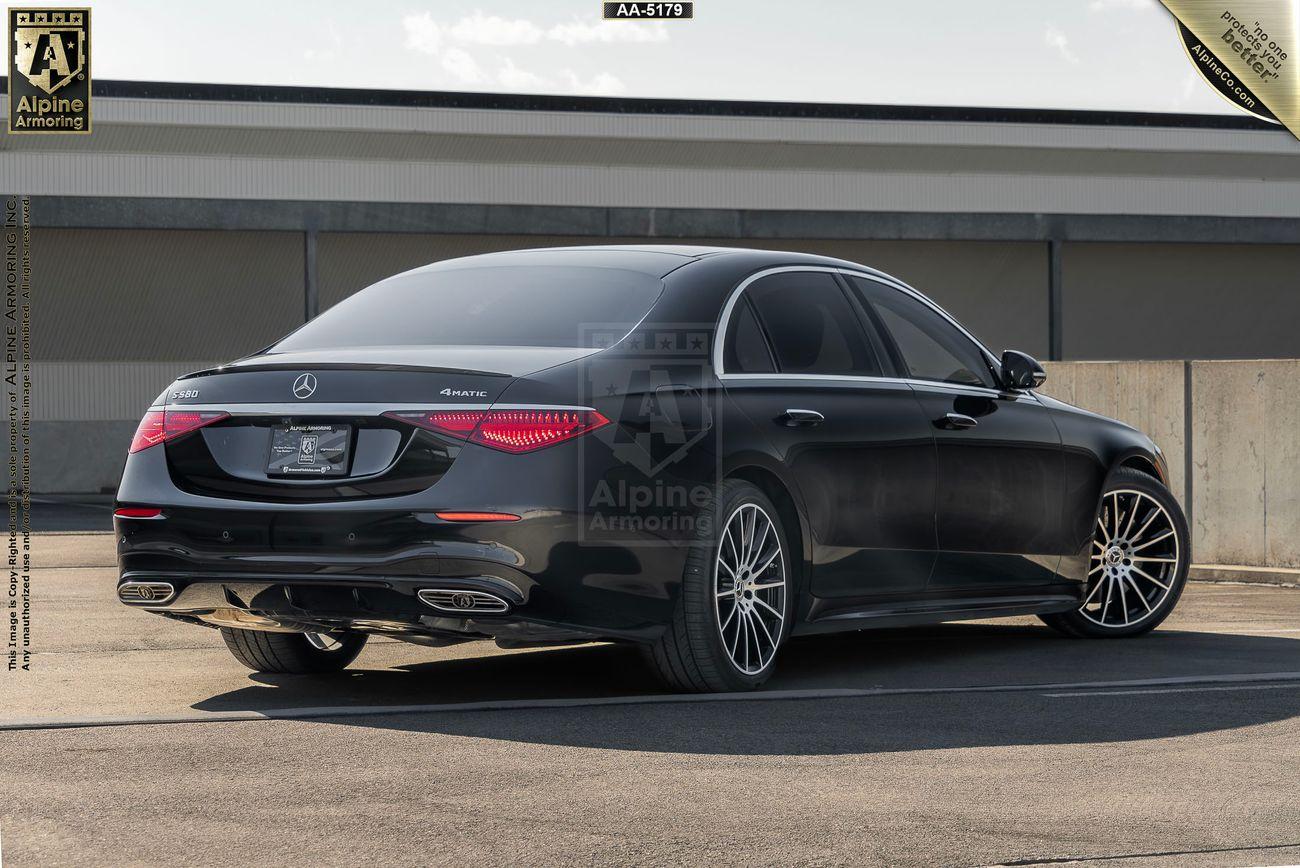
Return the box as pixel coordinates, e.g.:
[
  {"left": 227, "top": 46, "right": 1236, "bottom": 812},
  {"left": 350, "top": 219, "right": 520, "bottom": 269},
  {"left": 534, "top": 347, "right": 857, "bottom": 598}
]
[{"left": 745, "top": 272, "right": 880, "bottom": 377}]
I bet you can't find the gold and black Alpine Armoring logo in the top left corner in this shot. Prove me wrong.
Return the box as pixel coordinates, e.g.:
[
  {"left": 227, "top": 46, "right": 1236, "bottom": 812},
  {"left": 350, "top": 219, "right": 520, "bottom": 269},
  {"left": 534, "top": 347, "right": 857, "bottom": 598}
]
[{"left": 9, "top": 9, "right": 90, "bottom": 133}]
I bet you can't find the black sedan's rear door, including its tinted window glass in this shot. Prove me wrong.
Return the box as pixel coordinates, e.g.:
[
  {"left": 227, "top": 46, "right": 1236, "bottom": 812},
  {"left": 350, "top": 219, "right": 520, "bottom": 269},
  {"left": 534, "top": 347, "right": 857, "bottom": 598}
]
[{"left": 722, "top": 269, "right": 936, "bottom": 598}]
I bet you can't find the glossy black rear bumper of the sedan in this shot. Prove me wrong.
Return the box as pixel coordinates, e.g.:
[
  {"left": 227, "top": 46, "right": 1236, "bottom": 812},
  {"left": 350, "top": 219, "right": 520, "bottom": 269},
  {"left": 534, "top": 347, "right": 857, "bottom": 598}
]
[{"left": 114, "top": 415, "right": 712, "bottom": 641}]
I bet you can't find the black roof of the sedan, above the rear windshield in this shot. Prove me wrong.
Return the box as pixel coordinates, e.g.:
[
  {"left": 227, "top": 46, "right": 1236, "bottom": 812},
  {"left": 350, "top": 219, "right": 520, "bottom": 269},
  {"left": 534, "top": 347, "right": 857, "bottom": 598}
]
[{"left": 415, "top": 244, "right": 880, "bottom": 277}]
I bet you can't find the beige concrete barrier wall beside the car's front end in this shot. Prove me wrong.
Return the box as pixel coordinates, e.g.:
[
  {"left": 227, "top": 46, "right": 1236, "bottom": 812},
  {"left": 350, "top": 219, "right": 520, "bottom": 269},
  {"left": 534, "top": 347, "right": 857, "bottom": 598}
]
[{"left": 1043, "top": 359, "right": 1300, "bottom": 568}]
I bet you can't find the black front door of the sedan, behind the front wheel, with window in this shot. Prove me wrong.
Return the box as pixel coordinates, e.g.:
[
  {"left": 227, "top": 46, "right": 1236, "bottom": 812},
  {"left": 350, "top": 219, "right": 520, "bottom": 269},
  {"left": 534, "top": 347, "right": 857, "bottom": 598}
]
[{"left": 849, "top": 277, "right": 1065, "bottom": 591}]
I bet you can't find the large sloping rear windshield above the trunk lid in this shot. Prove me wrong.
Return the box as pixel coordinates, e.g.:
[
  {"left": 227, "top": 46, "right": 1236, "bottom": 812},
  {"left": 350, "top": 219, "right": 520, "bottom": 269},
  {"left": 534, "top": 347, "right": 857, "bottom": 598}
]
[{"left": 270, "top": 266, "right": 663, "bottom": 352}]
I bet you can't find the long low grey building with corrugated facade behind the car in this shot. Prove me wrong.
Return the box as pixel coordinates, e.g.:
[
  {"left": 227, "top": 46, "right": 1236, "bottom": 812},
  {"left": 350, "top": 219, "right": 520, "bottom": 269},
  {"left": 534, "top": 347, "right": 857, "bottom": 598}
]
[{"left": 0, "top": 83, "right": 1300, "bottom": 491}]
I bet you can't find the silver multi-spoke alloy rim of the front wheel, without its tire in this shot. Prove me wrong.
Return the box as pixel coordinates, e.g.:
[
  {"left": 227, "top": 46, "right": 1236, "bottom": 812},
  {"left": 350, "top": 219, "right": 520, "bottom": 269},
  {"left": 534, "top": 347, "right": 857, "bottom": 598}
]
[{"left": 1079, "top": 489, "right": 1182, "bottom": 628}]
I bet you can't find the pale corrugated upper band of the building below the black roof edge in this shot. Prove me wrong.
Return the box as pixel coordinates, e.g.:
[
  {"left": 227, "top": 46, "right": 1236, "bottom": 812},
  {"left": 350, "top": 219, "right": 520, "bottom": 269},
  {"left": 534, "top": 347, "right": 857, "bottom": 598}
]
[{"left": 0, "top": 87, "right": 1300, "bottom": 218}]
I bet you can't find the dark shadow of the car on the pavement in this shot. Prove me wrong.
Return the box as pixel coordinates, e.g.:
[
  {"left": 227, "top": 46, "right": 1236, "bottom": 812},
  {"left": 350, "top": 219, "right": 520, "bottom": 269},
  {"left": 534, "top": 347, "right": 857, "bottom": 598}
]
[{"left": 194, "top": 624, "right": 1300, "bottom": 755}]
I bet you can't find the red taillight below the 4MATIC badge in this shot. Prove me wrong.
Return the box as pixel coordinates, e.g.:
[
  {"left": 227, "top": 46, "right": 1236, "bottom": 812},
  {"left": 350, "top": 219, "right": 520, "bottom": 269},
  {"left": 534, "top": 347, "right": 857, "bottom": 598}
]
[{"left": 385, "top": 407, "right": 610, "bottom": 452}]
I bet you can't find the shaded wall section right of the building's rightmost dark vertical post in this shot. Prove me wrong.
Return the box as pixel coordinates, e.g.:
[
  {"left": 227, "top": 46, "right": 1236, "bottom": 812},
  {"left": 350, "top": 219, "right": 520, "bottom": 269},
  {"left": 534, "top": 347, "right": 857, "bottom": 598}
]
[{"left": 1062, "top": 239, "right": 1300, "bottom": 359}]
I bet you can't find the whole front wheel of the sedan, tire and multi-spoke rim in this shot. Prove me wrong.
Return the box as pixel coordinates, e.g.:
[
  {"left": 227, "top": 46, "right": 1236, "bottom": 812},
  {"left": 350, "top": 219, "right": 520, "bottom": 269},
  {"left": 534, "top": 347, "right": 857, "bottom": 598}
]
[{"left": 1044, "top": 468, "right": 1188, "bottom": 635}]
